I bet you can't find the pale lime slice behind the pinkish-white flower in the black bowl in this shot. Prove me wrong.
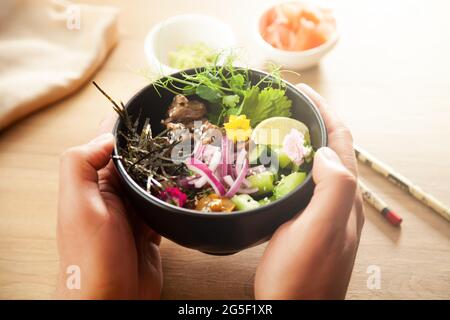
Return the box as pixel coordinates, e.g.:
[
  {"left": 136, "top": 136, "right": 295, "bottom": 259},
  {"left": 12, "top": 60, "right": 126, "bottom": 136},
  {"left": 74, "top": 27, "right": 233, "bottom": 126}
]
[{"left": 252, "top": 117, "right": 309, "bottom": 146}]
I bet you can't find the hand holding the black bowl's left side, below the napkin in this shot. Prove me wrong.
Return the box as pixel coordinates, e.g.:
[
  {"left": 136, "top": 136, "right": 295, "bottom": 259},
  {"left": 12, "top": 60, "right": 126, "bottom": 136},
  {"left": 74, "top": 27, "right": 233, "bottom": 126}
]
[{"left": 56, "top": 118, "right": 162, "bottom": 299}]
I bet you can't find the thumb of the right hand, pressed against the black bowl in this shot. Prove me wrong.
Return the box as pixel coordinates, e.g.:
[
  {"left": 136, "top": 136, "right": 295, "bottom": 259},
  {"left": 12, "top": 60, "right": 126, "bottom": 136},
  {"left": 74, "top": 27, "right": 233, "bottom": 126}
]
[{"left": 302, "top": 147, "right": 357, "bottom": 228}]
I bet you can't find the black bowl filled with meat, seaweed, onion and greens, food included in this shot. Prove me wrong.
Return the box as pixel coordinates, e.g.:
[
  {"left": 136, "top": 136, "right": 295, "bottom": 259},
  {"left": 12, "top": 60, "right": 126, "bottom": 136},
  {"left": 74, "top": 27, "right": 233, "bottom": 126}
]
[{"left": 112, "top": 68, "right": 327, "bottom": 255}]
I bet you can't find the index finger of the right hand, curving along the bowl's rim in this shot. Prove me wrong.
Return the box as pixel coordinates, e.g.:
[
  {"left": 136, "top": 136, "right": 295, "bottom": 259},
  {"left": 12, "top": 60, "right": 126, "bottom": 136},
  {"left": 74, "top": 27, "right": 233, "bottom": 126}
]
[{"left": 297, "top": 83, "right": 358, "bottom": 176}]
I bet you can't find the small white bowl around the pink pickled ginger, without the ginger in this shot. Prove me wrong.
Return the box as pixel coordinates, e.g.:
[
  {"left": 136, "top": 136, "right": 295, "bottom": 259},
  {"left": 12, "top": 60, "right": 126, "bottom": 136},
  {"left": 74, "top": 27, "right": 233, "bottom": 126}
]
[{"left": 253, "top": 1, "right": 339, "bottom": 71}]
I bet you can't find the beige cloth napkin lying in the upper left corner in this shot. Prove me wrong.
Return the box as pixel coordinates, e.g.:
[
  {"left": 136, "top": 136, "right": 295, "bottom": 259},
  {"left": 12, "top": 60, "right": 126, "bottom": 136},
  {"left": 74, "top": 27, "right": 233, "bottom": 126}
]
[{"left": 0, "top": 0, "right": 118, "bottom": 131}]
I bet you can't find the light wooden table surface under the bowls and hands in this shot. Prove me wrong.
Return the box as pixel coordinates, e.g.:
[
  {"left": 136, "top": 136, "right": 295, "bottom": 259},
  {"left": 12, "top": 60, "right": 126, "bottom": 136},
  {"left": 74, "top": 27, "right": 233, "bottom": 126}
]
[{"left": 0, "top": 0, "right": 450, "bottom": 299}]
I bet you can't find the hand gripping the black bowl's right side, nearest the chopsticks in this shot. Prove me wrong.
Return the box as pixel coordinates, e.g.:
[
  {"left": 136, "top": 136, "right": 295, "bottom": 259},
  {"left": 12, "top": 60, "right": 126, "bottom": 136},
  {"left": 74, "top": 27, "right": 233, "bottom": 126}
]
[{"left": 255, "top": 84, "right": 364, "bottom": 299}]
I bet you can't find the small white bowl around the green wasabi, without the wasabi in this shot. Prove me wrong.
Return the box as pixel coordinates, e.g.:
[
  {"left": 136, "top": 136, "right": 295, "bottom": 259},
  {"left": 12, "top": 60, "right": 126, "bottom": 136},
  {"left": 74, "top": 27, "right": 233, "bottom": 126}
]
[{"left": 144, "top": 14, "right": 236, "bottom": 75}]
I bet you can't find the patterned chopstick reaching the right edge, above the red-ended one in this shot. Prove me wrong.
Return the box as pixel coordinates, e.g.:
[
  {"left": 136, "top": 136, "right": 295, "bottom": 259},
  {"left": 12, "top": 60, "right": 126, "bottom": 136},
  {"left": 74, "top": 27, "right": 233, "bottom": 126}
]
[{"left": 353, "top": 145, "right": 450, "bottom": 221}]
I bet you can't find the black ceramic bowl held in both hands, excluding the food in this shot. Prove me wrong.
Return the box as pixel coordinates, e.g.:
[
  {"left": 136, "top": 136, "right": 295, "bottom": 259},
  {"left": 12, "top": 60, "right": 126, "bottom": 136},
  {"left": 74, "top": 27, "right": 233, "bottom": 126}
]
[{"left": 113, "top": 70, "right": 327, "bottom": 254}]
